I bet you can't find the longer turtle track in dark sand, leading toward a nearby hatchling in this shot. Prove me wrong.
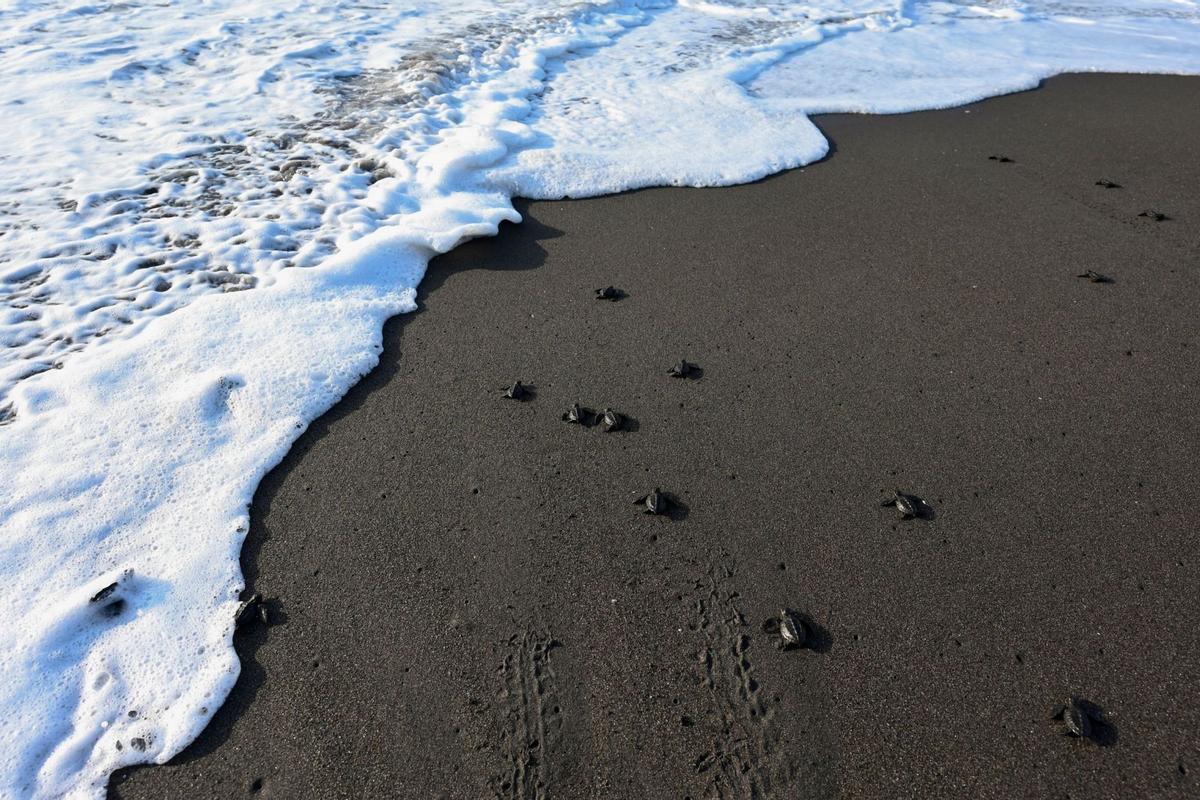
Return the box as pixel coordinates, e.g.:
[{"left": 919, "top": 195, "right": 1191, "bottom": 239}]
[{"left": 696, "top": 566, "right": 798, "bottom": 800}]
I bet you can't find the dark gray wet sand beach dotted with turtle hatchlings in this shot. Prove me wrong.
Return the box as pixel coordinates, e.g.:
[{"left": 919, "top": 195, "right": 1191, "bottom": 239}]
[{"left": 112, "top": 76, "right": 1200, "bottom": 800}]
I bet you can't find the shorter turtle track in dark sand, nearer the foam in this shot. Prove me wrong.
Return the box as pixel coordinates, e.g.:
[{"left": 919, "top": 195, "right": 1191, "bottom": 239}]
[{"left": 496, "top": 631, "right": 563, "bottom": 800}]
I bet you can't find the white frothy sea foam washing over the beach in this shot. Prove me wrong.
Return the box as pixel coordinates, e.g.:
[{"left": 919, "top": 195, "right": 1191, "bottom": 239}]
[{"left": 0, "top": 0, "right": 1200, "bottom": 798}]
